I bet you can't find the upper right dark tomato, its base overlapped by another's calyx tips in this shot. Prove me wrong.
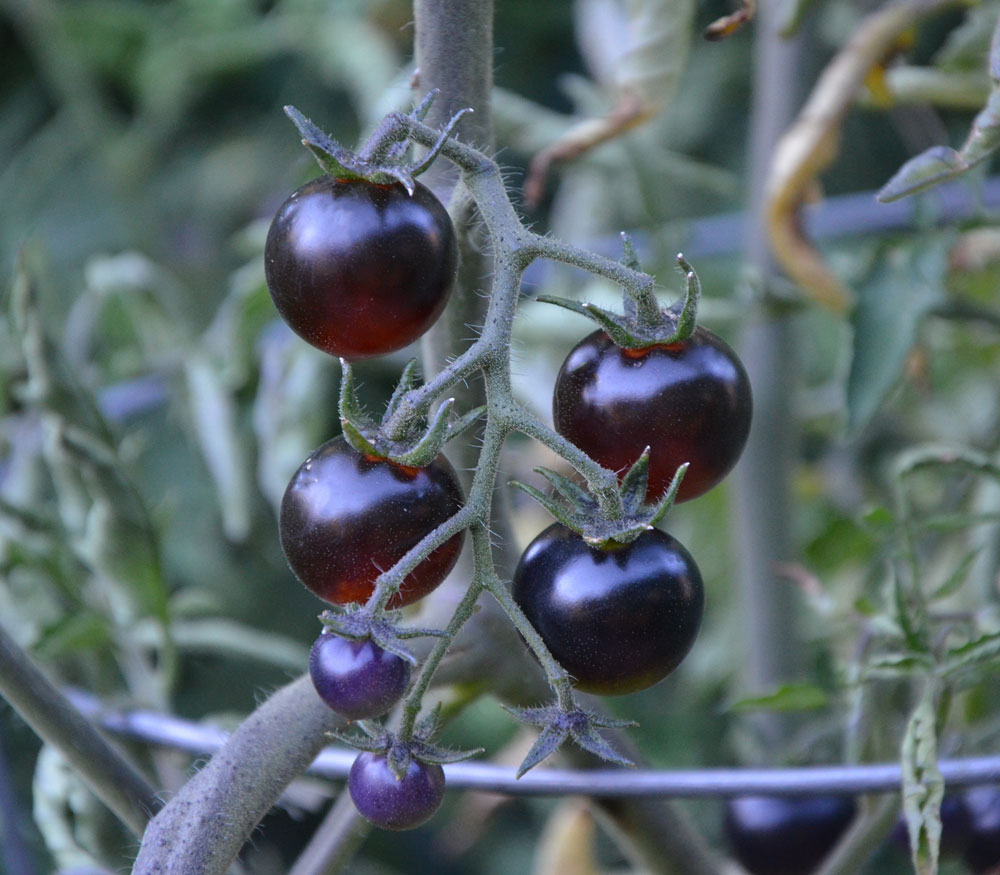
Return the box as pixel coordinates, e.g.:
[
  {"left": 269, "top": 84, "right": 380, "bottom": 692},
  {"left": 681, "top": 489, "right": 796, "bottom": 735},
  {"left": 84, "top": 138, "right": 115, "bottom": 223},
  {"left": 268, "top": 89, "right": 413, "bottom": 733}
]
[{"left": 552, "top": 327, "right": 753, "bottom": 501}]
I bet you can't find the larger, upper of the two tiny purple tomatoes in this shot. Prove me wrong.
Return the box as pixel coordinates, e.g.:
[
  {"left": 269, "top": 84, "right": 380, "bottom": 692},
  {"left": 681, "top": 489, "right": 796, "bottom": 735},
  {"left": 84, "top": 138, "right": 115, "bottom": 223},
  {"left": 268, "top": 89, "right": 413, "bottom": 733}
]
[{"left": 309, "top": 632, "right": 410, "bottom": 720}]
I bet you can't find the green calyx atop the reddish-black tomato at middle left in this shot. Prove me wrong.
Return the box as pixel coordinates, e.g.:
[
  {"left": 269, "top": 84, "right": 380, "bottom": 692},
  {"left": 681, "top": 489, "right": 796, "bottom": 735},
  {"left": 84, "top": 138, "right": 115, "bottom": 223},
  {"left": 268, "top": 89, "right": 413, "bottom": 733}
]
[{"left": 339, "top": 359, "right": 486, "bottom": 468}]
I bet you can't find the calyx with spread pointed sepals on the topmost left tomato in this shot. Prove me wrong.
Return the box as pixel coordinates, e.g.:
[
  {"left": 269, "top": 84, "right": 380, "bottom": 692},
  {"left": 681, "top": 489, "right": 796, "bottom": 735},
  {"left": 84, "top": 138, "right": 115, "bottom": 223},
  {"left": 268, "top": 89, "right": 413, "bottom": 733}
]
[{"left": 285, "top": 90, "right": 472, "bottom": 195}]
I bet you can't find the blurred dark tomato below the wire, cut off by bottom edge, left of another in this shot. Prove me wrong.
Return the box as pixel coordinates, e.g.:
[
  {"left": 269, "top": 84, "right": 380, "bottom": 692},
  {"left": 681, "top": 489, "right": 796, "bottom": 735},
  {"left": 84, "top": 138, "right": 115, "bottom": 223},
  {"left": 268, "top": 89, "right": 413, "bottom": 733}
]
[{"left": 723, "top": 796, "right": 857, "bottom": 875}]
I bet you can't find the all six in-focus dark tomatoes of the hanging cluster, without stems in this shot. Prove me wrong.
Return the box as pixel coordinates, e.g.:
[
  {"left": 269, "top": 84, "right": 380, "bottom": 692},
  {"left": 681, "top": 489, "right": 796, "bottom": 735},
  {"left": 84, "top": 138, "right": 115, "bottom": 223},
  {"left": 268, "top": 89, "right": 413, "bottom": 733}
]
[{"left": 265, "top": 149, "right": 751, "bottom": 829}]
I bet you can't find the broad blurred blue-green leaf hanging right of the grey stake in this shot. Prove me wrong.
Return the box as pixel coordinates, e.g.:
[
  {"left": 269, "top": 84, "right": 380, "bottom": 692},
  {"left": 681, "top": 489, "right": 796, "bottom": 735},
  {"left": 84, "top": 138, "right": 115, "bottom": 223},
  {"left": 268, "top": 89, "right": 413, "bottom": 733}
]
[{"left": 847, "top": 233, "right": 952, "bottom": 433}]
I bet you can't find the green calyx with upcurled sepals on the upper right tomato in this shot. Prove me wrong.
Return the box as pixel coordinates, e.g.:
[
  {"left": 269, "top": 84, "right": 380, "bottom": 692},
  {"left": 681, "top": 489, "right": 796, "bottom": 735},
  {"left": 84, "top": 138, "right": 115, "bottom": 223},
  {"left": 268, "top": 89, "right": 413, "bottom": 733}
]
[{"left": 536, "top": 246, "right": 701, "bottom": 349}]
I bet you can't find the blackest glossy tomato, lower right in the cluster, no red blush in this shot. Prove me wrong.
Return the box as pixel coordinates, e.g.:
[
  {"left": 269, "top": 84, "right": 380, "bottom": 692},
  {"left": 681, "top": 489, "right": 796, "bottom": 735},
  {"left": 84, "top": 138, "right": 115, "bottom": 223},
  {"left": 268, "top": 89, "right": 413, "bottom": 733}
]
[{"left": 513, "top": 523, "right": 705, "bottom": 695}]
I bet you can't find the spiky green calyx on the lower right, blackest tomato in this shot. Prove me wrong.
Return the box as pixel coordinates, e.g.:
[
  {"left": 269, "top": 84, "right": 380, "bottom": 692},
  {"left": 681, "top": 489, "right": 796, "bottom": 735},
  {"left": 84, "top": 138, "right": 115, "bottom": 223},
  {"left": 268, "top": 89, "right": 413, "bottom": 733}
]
[{"left": 511, "top": 447, "right": 688, "bottom": 548}]
